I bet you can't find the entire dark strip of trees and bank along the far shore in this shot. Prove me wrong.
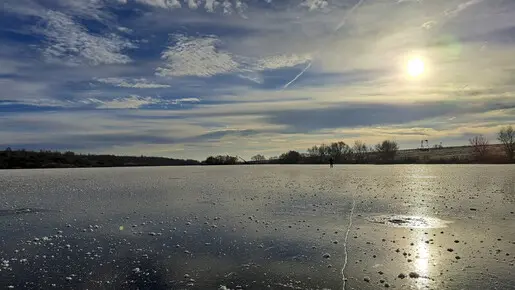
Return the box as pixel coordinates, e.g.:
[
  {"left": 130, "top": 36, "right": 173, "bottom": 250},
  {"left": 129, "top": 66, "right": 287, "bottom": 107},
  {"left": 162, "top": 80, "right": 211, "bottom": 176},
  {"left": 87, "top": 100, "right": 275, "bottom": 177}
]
[{"left": 0, "top": 126, "right": 515, "bottom": 169}]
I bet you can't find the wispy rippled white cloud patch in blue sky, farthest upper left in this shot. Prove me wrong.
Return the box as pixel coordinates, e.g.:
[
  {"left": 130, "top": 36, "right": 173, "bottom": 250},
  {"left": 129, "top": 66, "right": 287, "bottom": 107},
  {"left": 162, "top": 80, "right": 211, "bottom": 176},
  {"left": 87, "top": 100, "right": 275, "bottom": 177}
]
[{"left": 37, "top": 11, "right": 135, "bottom": 65}]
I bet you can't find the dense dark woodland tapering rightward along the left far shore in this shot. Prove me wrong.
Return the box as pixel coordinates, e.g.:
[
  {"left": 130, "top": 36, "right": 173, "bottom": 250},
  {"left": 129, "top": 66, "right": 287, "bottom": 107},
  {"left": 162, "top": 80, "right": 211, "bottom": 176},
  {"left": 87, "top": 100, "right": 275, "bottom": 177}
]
[{"left": 0, "top": 148, "right": 200, "bottom": 169}]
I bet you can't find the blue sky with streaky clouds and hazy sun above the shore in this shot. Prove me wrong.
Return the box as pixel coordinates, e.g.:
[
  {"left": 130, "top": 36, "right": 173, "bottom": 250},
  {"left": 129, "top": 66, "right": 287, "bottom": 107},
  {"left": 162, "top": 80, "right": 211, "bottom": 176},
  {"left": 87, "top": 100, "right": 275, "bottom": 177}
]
[{"left": 0, "top": 0, "right": 515, "bottom": 160}]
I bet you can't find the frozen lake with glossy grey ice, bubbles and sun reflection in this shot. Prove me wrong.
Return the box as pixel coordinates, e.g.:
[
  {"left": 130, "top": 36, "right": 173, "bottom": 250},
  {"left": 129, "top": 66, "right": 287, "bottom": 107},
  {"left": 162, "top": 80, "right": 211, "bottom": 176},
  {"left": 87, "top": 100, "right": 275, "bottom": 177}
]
[{"left": 0, "top": 165, "right": 515, "bottom": 289}]
